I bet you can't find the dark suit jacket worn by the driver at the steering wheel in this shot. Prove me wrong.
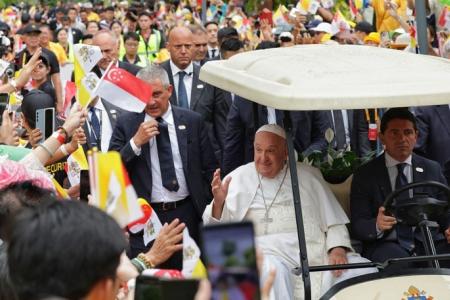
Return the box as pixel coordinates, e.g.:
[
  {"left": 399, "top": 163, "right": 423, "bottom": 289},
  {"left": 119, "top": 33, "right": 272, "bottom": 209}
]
[{"left": 350, "top": 154, "right": 450, "bottom": 249}]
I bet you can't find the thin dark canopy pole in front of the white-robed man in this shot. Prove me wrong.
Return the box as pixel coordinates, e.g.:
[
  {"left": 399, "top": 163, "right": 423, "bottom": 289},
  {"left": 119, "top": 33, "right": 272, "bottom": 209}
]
[{"left": 283, "top": 111, "right": 311, "bottom": 300}]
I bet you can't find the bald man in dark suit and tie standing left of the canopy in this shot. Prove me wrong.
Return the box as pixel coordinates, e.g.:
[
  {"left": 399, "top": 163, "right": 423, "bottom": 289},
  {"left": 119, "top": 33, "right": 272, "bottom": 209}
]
[{"left": 161, "top": 27, "right": 226, "bottom": 160}]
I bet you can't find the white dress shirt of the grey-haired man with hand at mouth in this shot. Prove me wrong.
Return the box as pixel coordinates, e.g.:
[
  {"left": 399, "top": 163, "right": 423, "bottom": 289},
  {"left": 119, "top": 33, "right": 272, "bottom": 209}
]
[{"left": 130, "top": 105, "right": 189, "bottom": 203}]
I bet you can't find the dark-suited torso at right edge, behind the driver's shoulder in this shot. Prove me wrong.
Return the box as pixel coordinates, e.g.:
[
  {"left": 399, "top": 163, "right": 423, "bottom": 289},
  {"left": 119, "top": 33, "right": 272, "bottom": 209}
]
[{"left": 414, "top": 105, "right": 450, "bottom": 182}]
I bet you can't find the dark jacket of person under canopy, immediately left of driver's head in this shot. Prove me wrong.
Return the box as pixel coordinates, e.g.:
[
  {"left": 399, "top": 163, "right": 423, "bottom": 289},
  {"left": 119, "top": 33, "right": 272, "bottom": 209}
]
[{"left": 328, "top": 109, "right": 372, "bottom": 157}]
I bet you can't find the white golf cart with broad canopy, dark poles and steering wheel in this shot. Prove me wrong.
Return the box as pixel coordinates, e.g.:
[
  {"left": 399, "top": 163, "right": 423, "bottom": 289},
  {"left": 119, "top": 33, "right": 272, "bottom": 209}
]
[{"left": 200, "top": 45, "right": 450, "bottom": 300}]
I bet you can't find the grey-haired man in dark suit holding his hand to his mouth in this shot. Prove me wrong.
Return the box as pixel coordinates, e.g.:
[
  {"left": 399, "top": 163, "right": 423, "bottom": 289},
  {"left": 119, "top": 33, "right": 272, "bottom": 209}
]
[{"left": 110, "top": 65, "right": 218, "bottom": 268}]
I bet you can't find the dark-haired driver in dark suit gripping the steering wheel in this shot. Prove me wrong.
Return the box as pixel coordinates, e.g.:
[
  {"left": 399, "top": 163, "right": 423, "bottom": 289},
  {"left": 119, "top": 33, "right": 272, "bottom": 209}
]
[{"left": 350, "top": 108, "right": 450, "bottom": 266}]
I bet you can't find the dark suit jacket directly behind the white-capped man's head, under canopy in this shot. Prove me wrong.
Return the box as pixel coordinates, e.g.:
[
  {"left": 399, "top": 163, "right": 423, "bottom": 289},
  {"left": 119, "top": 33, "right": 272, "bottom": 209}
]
[{"left": 222, "top": 96, "right": 331, "bottom": 174}]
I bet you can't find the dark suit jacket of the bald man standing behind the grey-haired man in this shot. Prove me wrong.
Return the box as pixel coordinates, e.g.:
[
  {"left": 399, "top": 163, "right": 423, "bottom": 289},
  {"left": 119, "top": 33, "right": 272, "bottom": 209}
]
[{"left": 161, "top": 60, "right": 227, "bottom": 161}]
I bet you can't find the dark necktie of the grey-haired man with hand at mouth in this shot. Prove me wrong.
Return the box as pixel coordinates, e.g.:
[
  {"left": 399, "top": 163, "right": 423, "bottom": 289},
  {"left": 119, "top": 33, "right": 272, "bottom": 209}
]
[{"left": 156, "top": 118, "right": 179, "bottom": 192}]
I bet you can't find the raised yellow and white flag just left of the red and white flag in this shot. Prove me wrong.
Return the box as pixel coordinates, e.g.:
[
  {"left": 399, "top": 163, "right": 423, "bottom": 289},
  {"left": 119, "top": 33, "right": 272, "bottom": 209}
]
[{"left": 73, "top": 44, "right": 102, "bottom": 107}]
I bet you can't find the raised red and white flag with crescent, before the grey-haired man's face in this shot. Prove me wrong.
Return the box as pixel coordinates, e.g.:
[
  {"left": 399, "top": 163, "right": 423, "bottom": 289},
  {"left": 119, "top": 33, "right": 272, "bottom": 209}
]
[{"left": 94, "top": 66, "right": 152, "bottom": 112}]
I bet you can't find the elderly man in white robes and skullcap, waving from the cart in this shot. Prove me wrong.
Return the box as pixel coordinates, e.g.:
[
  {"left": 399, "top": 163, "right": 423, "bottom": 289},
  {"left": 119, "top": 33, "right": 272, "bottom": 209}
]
[{"left": 203, "top": 124, "right": 376, "bottom": 300}]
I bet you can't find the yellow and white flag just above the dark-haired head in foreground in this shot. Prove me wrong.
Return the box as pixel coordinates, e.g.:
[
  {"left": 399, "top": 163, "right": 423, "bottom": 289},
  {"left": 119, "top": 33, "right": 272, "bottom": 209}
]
[{"left": 88, "top": 151, "right": 143, "bottom": 227}]
